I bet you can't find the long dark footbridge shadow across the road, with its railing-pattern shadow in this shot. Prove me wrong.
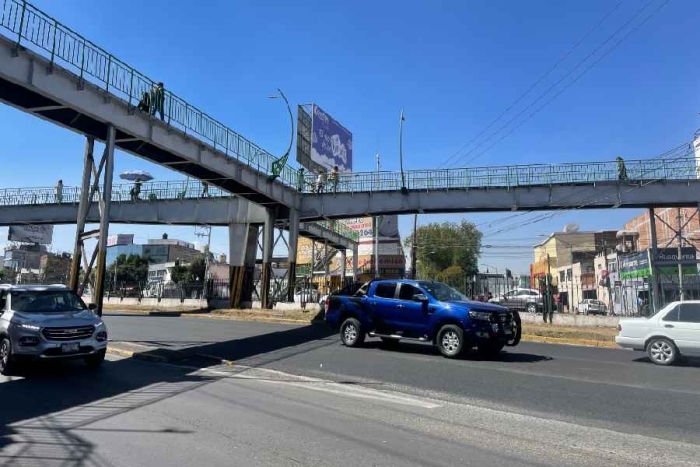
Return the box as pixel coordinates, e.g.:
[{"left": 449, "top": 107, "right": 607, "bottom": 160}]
[{"left": 0, "top": 325, "right": 336, "bottom": 467}]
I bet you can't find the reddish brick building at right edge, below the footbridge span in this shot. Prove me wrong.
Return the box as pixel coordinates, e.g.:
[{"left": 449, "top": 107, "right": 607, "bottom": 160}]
[{"left": 623, "top": 208, "right": 700, "bottom": 250}]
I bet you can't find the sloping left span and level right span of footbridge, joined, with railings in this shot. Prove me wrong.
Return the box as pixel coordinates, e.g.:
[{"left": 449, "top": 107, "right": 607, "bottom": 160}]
[{"left": 0, "top": 0, "right": 700, "bottom": 225}]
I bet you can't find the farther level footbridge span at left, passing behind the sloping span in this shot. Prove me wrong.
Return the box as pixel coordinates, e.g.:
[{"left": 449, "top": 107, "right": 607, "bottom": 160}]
[{"left": 0, "top": 180, "right": 358, "bottom": 250}]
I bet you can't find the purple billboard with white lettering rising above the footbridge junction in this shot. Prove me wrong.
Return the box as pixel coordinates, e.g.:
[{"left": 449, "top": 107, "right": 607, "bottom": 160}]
[{"left": 311, "top": 104, "right": 352, "bottom": 172}]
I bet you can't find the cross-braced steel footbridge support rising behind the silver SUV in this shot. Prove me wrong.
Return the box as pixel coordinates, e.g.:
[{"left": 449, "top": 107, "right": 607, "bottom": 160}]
[{"left": 70, "top": 124, "right": 116, "bottom": 316}]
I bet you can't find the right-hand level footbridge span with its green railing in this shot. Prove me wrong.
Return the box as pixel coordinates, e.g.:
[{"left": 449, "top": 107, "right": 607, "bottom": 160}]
[{"left": 300, "top": 153, "right": 700, "bottom": 220}]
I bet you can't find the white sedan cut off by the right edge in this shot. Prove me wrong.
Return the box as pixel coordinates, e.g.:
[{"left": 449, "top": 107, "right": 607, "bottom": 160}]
[{"left": 615, "top": 300, "right": 700, "bottom": 365}]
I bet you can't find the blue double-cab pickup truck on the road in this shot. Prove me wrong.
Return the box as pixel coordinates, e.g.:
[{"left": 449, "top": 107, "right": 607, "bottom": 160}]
[{"left": 325, "top": 280, "right": 521, "bottom": 358}]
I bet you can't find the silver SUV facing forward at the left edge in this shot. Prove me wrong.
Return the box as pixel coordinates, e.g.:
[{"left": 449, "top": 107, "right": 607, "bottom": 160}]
[{"left": 0, "top": 284, "right": 107, "bottom": 374}]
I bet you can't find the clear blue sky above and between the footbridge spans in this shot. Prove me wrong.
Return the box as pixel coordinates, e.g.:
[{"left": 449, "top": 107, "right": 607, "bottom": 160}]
[{"left": 0, "top": 0, "right": 700, "bottom": 271}]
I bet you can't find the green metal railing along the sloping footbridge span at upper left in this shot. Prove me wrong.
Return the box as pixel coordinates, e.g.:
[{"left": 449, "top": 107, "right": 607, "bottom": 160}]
[{"left": 0, "top": 0, "right": 297, "bottom": 186}]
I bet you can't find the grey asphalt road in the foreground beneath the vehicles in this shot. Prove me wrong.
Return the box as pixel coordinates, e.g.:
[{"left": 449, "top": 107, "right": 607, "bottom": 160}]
[{"left": 0, "top": 316, "right": 700, "bottom": 467}]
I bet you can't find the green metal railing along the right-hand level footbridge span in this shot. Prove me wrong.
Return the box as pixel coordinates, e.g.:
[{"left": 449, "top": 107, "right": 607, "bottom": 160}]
[{"left": 303, "top": 157, "right": 700, "bottom": 193}]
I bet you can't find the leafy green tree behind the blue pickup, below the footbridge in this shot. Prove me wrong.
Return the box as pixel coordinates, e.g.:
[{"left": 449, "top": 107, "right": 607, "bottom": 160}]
[{"left": 404, "top": 220, "right": 482, "bottom": 279}]
